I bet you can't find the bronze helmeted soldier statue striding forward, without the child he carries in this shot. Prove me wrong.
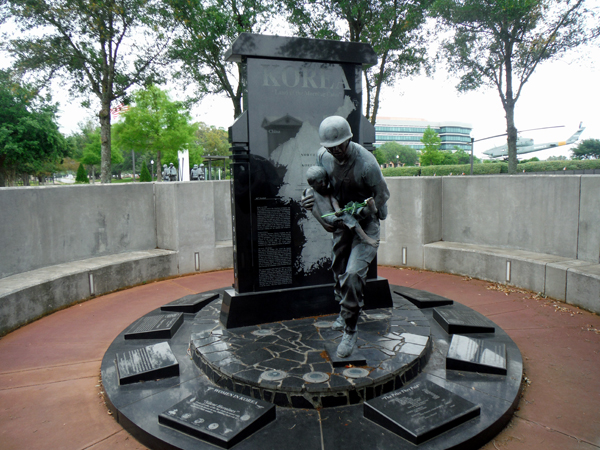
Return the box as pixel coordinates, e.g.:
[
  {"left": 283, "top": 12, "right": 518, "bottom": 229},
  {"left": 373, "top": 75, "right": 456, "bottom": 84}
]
[{"left": 302, "top": 116, "right": 390, "bottom": 358}]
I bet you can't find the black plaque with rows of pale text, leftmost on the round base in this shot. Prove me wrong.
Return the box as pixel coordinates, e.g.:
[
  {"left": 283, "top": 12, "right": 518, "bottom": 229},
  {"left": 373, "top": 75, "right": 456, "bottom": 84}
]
[{"left": 115, "top": 342, "right": 179, "bottom": 385}]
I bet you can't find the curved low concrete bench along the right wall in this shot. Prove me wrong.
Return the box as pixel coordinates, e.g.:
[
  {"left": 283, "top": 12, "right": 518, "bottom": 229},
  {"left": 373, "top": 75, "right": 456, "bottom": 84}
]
[{"left": 423, "top": 241, "right": 600, "bottom": 313}]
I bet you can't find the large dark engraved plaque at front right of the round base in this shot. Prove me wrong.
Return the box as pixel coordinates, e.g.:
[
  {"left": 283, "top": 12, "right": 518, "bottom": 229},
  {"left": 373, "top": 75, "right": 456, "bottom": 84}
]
[{"left": 364, "top": 380, "right": 480, "bottom": 445}]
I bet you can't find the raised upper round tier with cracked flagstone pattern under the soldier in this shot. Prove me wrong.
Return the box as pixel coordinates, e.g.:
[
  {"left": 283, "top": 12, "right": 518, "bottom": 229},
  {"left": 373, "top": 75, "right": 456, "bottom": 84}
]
[{"left": 190, "top": 296, "right": 431, "bottom": 409}]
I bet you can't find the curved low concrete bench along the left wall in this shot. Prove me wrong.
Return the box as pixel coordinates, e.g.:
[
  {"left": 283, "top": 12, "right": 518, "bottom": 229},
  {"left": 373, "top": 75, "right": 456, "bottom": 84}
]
[{"left": 0, "top": 249, "right": 178, "bottom": 336}]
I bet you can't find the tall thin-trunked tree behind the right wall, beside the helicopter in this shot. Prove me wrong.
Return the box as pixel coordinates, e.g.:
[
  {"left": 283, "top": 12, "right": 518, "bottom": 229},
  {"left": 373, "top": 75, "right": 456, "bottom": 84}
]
[{"left": 434, "top": 0, "right": 593, "bottom": 173}]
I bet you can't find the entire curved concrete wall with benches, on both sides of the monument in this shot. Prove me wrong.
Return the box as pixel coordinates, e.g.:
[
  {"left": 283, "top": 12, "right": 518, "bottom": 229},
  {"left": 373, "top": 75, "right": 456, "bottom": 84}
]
[{"left": 0, "top": 175, "right": 600, "bottom": 331}]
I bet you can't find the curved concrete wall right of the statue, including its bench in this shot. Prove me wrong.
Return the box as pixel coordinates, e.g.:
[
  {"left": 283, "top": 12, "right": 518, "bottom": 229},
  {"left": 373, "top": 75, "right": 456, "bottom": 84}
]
[{"left": 378, "top": 175, "right": 600, "bottom": 313}]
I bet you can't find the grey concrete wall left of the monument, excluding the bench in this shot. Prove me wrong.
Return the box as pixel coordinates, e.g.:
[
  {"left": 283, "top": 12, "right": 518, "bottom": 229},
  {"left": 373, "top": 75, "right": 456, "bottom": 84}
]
[{"left": 0, "top": 181, "right": 232, "bottom": 279}]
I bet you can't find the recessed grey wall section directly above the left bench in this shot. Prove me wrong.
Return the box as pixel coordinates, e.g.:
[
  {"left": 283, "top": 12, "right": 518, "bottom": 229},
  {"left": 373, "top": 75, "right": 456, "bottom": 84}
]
[{"left": 0, "top": 183, "right": 156, "bottom": 278}]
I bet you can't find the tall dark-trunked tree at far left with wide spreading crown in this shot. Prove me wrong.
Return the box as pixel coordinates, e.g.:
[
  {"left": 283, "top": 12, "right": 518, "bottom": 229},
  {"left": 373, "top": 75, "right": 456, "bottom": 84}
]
[{"left": 0, "top": 0, "right": 170, "bottom": 183}]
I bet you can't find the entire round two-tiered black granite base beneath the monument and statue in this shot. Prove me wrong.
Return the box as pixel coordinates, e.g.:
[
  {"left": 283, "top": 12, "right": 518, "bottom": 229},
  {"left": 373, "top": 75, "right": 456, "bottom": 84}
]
[{"left": 102, "top": 286, "right": 523, "bottom": 450}]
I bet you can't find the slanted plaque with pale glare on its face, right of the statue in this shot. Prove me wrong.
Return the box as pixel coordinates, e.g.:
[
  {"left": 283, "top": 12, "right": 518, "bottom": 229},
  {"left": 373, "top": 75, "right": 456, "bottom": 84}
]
[{"left": 446, "top": 334, "right": 506, "bottom": 375}]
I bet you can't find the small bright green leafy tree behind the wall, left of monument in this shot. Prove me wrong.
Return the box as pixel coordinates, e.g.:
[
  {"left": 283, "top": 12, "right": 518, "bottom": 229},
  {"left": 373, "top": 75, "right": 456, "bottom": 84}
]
[{"left": 115, "top": 85, "right": 197, "bottom": 181}]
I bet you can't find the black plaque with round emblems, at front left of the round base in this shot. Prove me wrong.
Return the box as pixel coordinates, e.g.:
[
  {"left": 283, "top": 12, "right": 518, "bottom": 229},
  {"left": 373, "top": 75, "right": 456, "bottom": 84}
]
[{"left": 158, "top": 387, "right": 276, "bottom": 448}]
